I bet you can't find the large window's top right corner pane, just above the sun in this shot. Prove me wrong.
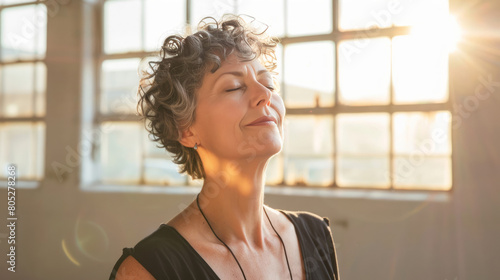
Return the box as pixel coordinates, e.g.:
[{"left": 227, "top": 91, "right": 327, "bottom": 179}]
[{"left": 391, "top": 0, "right": 449, "bottom": 26}]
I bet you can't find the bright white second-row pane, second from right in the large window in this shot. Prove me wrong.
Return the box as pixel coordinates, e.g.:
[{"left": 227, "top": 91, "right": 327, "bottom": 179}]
[{"left": 338, "top": 38, "right": 391, "bottom": 105}]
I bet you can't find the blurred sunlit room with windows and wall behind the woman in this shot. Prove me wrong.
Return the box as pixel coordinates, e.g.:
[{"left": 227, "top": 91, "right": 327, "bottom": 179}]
[{"left": 0, "top": 0, "right": 500, "bottom": 280}]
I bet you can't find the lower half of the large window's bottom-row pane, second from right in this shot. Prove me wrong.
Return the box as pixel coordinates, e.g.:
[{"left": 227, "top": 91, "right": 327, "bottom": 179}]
[{"left": 337, "top": 155, "right": 390, "bottom": 188}]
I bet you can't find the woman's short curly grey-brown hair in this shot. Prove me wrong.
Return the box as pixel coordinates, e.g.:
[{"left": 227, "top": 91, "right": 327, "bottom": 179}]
[{"left": 137, "top": 15, "right": 278, "bottom": 179}]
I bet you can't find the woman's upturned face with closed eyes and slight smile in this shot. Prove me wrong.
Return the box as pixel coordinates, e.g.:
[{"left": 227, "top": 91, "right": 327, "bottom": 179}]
[{"left": 192, "top": 55, "right": 285, "bottom": 160}]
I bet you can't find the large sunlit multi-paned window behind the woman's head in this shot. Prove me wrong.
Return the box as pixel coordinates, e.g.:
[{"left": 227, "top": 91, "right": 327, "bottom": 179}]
[{"left": 97, "top": 0, "right": 453, "bottom": 190}]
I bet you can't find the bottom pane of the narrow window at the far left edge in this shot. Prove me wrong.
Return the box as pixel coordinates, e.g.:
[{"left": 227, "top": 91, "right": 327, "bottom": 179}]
[{"left": 0, "top": 123, "right": 45, "bottom": 180}]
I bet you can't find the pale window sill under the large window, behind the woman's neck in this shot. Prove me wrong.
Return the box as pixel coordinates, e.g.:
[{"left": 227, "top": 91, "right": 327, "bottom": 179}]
[{"left": 81, "top": 184, "right": 451, "bottom": 202}]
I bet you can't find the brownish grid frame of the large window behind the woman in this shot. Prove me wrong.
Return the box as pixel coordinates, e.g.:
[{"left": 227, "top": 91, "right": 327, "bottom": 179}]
[{"left": 94, "top": 0, "right": 455, "bottom": 192}]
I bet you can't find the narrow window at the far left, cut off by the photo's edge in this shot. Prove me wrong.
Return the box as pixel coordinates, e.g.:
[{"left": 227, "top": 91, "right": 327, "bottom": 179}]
[{"left": 0, "top": 0, "right": 47, "bottom": 181}]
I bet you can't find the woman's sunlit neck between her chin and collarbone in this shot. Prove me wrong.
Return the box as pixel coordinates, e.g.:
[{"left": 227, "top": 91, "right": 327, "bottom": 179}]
[{"left": 199, "top": 155, "right": 269, "bottom": 248}]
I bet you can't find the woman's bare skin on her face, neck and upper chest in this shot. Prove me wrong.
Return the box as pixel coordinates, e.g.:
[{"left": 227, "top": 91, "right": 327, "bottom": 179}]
[{"left": 117, "top": 55, "right": 305, "bottom": 279}]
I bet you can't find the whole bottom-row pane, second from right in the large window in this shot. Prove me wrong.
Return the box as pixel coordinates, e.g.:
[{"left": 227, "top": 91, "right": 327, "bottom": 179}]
[{"left": 336, "top": 113, "right": 390, "bottom": 188}]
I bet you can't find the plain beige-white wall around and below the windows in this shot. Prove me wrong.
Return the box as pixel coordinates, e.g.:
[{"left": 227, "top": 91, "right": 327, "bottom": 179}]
[{"left": 0, "top": 1, "right": 500, "bottom": 280}]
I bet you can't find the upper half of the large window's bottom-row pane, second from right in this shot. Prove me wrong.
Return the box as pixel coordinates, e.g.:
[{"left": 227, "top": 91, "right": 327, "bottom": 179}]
[{"left": 337, "top": 113, "right": 390, "bottom": 156}]
